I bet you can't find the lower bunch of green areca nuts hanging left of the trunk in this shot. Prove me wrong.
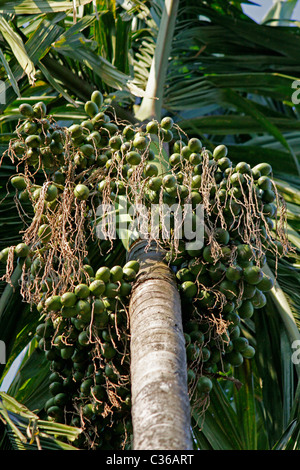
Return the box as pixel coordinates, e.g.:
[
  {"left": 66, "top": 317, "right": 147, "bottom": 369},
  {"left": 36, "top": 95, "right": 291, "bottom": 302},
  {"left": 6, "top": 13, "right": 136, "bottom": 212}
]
[{"left": 35, "top": 261, "right": 139, "bottom": 449}]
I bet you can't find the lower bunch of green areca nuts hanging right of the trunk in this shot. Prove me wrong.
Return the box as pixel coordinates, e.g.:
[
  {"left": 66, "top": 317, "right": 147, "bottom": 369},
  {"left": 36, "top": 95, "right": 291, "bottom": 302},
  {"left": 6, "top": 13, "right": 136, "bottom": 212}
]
[{"left": 176, "top": 235, "right": 273, "bottom": 398}]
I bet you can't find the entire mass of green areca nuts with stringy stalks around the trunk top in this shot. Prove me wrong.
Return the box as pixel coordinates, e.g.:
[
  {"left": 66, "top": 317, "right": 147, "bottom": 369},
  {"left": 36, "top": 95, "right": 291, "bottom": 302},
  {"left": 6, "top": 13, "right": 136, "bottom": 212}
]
[{"left": 0, "top": 87, "right": 286, "bottom": 448}]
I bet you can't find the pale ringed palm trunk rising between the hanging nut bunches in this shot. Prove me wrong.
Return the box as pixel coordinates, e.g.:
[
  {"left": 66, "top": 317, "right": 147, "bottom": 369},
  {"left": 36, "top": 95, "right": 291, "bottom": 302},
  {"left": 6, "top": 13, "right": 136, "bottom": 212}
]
[{"left": 129, "top": 241, "right": 193, "bottom": 450}]
